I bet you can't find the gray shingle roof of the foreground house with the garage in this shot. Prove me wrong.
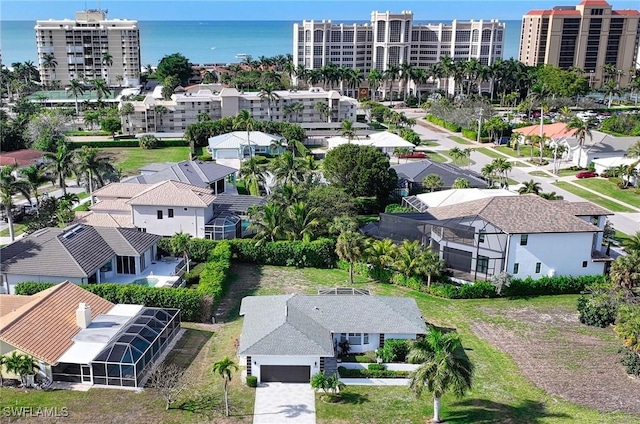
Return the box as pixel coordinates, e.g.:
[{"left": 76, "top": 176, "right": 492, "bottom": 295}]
[{"left": 238, "top": 295, "right": 426, "bottom": 356}]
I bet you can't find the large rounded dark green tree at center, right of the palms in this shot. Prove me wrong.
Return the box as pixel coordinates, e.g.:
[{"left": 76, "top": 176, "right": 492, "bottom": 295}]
[{"left": 323, "top": 144, "right": 398, "bottom": 199}]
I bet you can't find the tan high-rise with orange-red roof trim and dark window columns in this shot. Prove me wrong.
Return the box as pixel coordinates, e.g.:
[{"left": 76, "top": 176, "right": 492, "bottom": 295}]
[{"left": 519, "top": 0, "right": 640, "bottom": 88}]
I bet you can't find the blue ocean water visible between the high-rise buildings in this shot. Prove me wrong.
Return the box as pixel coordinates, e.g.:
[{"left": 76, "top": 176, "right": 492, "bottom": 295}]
[{"left": 0, "top": 21, "right": 521, "bottom": 66}]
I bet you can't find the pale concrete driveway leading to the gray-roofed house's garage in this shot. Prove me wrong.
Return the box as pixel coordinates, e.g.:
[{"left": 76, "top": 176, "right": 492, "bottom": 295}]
[{"left": 253, "top": 383, "right": 316, "bottom": 424}]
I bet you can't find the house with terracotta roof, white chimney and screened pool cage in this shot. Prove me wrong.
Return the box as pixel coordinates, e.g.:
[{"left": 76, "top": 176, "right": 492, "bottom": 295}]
[{"left": 0, "top": 282, "right": 180, "bottom": 387}]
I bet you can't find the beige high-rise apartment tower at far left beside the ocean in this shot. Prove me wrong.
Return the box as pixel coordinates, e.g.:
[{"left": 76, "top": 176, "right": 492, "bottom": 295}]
[{"left": 35, "top": 10, "right": 140, "bottom": 87}]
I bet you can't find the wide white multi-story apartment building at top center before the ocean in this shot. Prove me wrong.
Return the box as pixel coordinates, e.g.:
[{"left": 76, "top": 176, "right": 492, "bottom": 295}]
[{"left": 293, "top": 11, "right": 505, "bottom": 96}]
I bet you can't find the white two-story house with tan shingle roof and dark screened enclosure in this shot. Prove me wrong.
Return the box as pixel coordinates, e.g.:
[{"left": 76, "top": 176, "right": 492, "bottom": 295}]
[{"left": 378, "top": 189, "right": 612, "bottom": 281}]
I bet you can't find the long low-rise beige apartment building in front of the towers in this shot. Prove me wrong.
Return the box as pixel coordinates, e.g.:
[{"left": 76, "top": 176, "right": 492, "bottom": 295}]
[{"left": 120, "top": 84, "right": 358, "bottom": 134}]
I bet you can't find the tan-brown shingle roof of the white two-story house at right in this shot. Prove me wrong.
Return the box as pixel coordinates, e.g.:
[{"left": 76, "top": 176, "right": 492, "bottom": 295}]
[{"left": 428, "top": 194, "right": 602, "bottom": 234}]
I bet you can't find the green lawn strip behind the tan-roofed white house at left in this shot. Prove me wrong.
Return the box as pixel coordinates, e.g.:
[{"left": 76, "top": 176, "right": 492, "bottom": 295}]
[{"left": 100, "top": 146, "right": 189, "bottom": 175}]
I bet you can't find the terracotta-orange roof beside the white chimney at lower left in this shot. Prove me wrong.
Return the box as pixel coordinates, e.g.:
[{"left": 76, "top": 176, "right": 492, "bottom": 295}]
[{"left": 0, "top": 281, "right": 114, "bottom": 364}]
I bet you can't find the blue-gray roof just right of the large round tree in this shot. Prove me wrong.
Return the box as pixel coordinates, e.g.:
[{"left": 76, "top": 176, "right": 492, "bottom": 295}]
[{"left": 391, "top": 159, "right": 487, "bottom": 188}]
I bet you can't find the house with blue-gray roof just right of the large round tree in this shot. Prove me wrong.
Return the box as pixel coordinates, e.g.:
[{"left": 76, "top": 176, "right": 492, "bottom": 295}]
[{"left": 391, "top": 159, "right": 488, "bottom": 196}]
